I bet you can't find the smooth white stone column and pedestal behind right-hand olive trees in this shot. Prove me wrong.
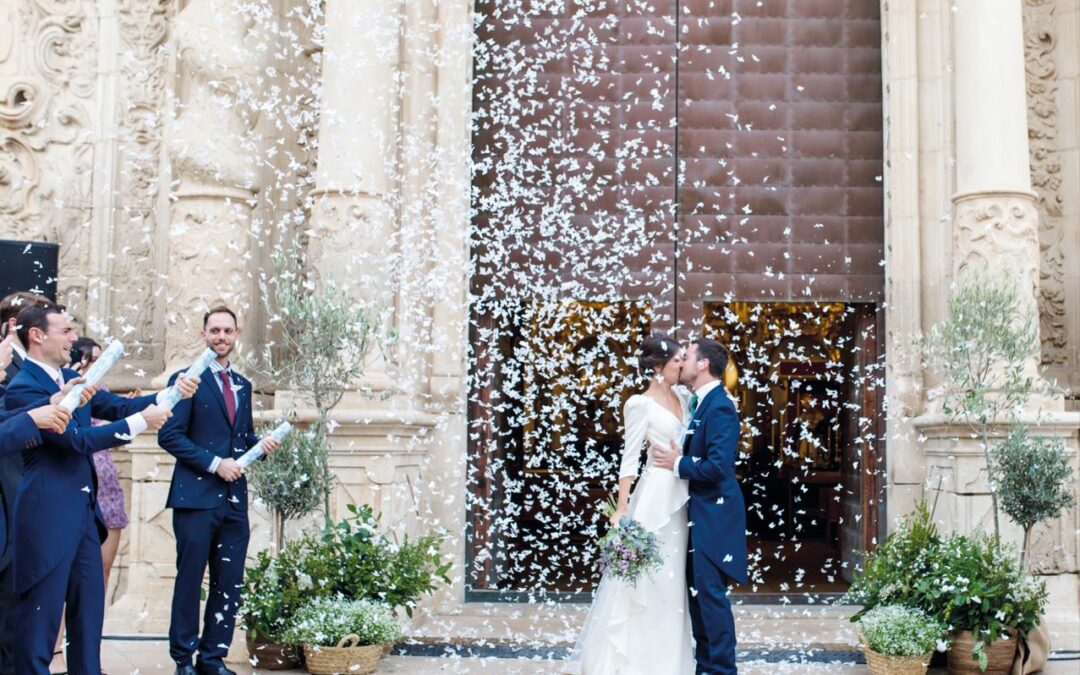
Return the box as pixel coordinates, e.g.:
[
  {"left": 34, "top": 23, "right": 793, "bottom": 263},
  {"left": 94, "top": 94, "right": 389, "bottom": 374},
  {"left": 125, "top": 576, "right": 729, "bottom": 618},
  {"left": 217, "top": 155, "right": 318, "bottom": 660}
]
[{"left": 914, "top": 0, "right": 1080, "bottom": 648}]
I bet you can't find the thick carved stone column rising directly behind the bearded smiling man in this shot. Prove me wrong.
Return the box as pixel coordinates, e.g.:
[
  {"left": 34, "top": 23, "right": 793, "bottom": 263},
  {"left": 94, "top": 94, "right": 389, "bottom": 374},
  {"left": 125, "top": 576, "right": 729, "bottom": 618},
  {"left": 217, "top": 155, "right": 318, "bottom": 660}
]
[{"left": 157, "top": 0, "right": 270, "bottom": 377}]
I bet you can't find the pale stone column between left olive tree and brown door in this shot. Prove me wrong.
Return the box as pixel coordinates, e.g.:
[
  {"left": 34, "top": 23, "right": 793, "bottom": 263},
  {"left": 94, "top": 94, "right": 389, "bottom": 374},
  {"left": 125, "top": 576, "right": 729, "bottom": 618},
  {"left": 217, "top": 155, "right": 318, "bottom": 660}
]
[{"left": 308, "top": 0, "right": 406, "bottom": 390}]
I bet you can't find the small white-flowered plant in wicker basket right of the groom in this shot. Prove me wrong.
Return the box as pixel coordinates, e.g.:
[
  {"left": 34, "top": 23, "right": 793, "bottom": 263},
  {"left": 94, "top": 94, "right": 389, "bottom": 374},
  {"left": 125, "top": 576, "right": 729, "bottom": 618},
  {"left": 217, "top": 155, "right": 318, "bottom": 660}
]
[{"left": 859, "top": 605, "right": 942, "bottom": 675}]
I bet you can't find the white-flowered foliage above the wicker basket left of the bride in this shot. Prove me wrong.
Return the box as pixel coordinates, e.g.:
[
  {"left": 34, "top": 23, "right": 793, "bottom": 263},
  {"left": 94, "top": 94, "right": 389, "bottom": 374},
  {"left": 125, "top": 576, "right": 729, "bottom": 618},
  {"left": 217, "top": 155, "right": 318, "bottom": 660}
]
[{"left": 284, "top": 595, "right": 401, "bottom": 647}]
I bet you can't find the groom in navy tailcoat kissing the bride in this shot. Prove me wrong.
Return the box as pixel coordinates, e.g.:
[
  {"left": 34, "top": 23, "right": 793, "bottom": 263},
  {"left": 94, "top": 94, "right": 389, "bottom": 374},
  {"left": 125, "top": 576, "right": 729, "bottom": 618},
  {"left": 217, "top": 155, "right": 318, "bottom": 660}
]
[{"left": 652, "top": 338, "right": 746, "bottom": 675}]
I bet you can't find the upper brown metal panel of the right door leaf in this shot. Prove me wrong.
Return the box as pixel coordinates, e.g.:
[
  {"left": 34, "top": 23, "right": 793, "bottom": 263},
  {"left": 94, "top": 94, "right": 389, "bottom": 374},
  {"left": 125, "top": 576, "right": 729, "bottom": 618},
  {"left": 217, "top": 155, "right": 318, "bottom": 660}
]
[{"left": 677, "top": 0, "right": 885, "bottom": 329}]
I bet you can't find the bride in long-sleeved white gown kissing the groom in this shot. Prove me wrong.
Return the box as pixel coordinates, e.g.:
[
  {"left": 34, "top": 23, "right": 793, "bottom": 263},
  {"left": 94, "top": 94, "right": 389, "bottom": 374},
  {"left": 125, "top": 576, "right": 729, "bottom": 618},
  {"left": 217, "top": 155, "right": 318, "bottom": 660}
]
[{"left": 566, "top": 333, "right": 694, "bottom": 675}]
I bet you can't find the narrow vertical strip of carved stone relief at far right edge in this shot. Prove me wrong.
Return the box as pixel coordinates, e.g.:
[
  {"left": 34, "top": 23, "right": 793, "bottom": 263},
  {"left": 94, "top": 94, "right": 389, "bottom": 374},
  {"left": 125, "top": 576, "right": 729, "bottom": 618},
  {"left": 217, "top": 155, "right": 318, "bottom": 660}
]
[{"left": 1024, "top": 0, "right": 1068, "bottom": 365}]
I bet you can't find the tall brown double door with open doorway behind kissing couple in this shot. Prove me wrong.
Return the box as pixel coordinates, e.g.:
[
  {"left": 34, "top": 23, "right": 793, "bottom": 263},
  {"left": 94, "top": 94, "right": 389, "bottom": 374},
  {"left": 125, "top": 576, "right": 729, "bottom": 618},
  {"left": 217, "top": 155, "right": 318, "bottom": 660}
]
[{"left": 468, "top": 0, "right": 883, "bottom": 597}]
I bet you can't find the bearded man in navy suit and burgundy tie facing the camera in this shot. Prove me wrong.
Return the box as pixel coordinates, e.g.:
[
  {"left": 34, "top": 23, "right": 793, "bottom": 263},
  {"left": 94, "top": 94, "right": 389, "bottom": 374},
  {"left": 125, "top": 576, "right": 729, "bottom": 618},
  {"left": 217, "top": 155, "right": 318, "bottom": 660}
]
[{"left": 158, "top": 306, "right": 279, "bottom": 675}]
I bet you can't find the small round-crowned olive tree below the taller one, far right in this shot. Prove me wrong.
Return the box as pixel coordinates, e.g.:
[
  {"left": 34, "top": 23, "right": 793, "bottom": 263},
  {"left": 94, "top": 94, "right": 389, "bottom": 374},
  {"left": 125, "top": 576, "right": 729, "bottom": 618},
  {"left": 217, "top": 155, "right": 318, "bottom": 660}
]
[{"left": 994, "top": 424, "right": 1076, "bottom": 568}]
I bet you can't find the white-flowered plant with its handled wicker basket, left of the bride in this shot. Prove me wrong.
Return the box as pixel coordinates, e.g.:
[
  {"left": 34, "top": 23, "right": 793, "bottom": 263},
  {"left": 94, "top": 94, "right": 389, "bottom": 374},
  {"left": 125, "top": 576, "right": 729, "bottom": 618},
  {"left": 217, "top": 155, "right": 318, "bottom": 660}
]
[{"left": 285, "top": 595, "right": 401, "bottom": 675}]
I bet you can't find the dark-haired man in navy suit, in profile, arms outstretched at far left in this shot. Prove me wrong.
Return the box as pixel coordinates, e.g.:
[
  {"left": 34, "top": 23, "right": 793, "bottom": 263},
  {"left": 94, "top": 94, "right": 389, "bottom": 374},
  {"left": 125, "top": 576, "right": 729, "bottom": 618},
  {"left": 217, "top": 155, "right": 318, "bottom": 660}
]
[{"left": 6, "top": 305, "right": 195, "bottom": 675}]
